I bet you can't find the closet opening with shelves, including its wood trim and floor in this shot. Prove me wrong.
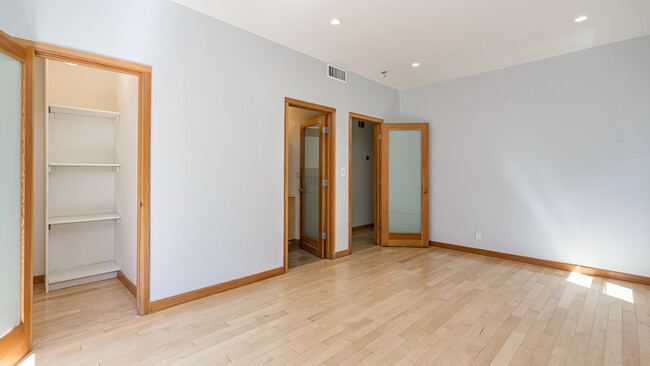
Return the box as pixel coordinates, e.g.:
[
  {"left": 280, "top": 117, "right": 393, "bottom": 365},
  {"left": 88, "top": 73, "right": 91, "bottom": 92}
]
[{"left": 22, "top": 40, "right": 151, "bottom": 324}]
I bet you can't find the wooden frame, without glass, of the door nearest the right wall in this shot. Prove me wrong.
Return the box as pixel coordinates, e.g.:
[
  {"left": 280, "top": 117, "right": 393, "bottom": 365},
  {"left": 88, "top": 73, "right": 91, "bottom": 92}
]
[{"left": 380, "top": 123, "right": 429, "bottom": 247}]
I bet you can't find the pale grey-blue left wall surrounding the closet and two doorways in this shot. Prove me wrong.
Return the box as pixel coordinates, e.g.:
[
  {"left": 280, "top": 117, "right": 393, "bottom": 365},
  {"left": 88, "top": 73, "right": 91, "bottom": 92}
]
[{"left": 0, "top": 0, "right": 399, "bottom": 301}]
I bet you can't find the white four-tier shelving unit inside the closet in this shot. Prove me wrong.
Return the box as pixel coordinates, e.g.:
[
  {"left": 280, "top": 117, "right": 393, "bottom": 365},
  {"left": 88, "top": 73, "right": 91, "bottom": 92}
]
[{"left": 45, "top": 105, "right": 120, "bottom": 291}]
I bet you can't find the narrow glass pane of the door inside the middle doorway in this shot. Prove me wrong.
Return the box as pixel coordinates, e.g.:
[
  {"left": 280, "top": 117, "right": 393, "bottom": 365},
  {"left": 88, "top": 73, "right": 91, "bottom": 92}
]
[{"left": 303, "top": 125, "right": 320, "bottom": 240}]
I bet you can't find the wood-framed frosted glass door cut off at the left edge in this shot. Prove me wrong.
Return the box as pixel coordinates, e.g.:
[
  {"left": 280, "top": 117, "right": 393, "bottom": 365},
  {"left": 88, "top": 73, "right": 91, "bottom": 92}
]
[{"left": 0, "top": 31, "right": 34, "bottom": 365}]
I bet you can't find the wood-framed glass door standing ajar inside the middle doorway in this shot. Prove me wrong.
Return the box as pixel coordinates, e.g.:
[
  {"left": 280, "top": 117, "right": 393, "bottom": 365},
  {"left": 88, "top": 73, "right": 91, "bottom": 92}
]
[{"left": 299, "top": 115, "right": 327, "bottom": 258}]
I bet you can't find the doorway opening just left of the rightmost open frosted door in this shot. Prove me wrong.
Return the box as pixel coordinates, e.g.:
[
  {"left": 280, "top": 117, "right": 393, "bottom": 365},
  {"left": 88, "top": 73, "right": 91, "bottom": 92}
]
[{"left": 348, "top": 113, "right": 383, "bottom": 253}]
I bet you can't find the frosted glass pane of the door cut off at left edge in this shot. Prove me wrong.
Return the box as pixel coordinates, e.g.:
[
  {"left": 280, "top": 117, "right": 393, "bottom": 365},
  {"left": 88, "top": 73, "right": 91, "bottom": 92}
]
[{"left": 0, "top": 52, "right": 23, "bottom": 337}]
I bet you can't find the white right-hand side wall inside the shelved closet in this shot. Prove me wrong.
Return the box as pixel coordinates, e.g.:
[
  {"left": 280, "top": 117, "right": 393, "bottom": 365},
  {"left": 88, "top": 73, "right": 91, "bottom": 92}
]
[{"left": 114, "top": 74, "right": 138, "bottom": 284}]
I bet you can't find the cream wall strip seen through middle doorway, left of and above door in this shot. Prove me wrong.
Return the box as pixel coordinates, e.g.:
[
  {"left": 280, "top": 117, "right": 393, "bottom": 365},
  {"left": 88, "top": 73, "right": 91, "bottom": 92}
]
[{"left": 287, "top": 107, "right": 321, "bottom": 239}]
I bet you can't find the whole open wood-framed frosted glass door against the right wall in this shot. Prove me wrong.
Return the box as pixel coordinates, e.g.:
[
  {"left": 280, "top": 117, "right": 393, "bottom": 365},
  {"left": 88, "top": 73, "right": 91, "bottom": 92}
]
[{"left": 381, "top": 123, "right": 429, "bottom": 247}]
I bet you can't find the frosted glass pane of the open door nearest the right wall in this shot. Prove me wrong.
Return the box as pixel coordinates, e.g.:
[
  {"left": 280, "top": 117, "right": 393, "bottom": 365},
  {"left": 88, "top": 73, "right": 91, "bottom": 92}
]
[{"left": 388, "top": 131, "right": 422, "bottom": 233}]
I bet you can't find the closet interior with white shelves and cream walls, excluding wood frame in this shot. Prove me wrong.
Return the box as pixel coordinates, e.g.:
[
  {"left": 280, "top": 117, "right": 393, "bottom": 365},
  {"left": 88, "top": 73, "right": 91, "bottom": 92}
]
[{"left": 34, "top": 58, "right": 138, "bottom": 292}]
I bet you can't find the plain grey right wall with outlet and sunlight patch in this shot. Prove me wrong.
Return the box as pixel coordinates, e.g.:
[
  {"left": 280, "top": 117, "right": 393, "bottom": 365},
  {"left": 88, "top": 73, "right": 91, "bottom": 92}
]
[{"left": 400, "top": 37, "right": 650, "bottom": 276}]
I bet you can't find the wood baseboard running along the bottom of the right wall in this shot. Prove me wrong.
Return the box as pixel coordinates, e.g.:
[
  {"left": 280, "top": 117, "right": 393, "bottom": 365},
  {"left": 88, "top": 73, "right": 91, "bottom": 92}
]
[{"left": 429, "top": 241, "right": 650, "bottom": 286}]
